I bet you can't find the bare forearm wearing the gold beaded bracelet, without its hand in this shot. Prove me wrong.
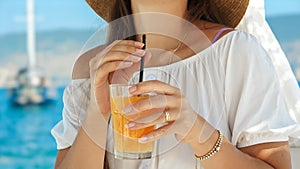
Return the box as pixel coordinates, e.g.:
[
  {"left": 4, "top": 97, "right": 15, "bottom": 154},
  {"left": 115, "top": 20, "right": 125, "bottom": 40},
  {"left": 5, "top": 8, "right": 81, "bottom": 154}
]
[{"left": 190, "top": 119, "right": 292, "bottom": 169}]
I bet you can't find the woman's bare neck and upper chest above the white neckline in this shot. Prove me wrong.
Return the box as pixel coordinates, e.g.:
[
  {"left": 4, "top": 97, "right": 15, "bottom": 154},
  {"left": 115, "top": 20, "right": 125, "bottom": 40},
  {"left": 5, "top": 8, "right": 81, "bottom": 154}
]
[{"left": 131, "top": 0, "right": 226, "bottom": 66}]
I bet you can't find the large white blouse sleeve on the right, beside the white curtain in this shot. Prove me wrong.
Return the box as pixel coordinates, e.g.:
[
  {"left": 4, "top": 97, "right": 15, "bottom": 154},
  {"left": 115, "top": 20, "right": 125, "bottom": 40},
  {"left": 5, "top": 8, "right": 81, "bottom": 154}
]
[{"left": 225, "top": 32, "right": 299, "bottom": 147}]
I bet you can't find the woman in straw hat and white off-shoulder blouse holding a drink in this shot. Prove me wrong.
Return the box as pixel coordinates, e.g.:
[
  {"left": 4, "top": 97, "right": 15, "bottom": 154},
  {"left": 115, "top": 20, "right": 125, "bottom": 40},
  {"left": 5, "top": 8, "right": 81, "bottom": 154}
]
[{"left": 52, "top": 0, "right": 298, "bottom": 169}]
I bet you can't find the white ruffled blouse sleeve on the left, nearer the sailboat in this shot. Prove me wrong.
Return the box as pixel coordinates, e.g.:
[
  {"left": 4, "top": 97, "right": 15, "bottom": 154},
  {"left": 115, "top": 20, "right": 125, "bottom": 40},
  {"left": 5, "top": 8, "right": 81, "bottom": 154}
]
[{"left": 51, "top": 80, "right": 90, "bottom": 149}]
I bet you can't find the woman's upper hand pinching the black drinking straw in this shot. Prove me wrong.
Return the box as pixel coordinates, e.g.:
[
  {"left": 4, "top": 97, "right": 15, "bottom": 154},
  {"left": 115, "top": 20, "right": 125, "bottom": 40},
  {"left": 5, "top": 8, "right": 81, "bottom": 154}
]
[{"left": 89, "top": 40, "right": 149, "bottom": 119}]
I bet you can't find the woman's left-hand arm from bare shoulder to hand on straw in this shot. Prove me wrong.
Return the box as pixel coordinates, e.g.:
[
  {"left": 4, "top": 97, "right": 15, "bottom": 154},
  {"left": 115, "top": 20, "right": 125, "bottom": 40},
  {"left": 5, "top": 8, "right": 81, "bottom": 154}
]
[{"left": 55, "top": 40, "right": 150, "bottom": 169}]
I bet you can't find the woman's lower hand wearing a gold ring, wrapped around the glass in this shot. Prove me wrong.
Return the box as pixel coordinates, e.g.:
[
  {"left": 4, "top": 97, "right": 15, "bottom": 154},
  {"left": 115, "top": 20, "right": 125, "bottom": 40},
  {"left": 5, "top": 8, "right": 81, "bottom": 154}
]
[{"left": 123, "top": 81, "right": 204, "bottom": 142}]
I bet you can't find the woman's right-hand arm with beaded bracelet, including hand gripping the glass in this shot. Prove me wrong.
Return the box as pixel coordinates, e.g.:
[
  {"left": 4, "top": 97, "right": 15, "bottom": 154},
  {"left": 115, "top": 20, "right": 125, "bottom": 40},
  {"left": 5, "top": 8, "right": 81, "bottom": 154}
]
[{"left": 123, "top": 81, "right": 291, "bottom": 169}]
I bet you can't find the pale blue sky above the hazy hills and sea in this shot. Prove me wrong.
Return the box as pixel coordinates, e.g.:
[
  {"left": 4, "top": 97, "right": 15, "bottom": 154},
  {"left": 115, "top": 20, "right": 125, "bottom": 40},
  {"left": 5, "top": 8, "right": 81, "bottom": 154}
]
[{"left": 0, "top": 0, "right": 300, "bottom": 35}]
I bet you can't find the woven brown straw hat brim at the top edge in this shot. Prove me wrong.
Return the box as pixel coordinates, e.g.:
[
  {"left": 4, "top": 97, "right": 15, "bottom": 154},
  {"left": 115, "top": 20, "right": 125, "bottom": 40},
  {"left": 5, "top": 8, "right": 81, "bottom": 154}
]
[{"left": 86, "top": 0, "right": 249, "bottom": 28}]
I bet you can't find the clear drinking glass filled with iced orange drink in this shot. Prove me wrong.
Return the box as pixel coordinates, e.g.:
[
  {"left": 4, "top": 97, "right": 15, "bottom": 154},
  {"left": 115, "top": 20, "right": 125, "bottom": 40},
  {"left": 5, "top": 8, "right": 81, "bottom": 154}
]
[{"left": 109, "top": 84, "right": 154, "bottom": 159}]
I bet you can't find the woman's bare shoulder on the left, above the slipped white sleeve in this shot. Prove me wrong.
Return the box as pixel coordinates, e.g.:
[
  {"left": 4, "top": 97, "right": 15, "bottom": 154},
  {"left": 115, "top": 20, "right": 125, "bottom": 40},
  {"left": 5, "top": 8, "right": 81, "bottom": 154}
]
[{"left": 72, "top": 45, "right": 106, "bottom": 79}]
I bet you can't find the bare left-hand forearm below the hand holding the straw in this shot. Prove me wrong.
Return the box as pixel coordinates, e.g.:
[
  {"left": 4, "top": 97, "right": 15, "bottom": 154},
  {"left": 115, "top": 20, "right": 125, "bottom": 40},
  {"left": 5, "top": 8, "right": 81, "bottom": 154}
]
[{"left": 55, "top": 106, "right": 107, "bottom": 169}]
